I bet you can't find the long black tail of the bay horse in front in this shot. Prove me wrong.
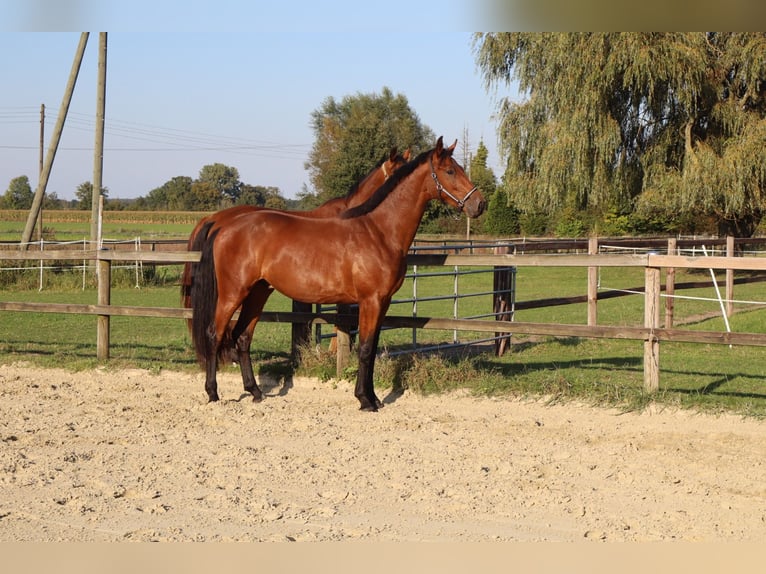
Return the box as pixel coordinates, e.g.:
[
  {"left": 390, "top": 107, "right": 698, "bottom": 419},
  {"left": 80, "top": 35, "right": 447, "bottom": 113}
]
[{"left": 191, "top": 222, "right": 218, "bottom": 368}]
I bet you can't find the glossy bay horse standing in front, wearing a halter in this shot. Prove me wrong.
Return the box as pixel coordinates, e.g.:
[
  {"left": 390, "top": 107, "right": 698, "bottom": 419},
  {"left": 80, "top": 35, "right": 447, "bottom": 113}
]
[{"left": 191, "top": 137, "right": 486, "bottom": 411}]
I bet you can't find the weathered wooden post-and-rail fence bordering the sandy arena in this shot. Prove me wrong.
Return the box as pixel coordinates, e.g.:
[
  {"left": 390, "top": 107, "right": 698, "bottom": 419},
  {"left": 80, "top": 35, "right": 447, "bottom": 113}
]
[{"left": 0, "top": 240, "right": 766, "bottom": 392}]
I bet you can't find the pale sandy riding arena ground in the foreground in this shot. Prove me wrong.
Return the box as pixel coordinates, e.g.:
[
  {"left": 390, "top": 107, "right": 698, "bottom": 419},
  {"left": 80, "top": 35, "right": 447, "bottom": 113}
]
[{"left": 0, "top": 364, "right": 766, "bottom": 542}]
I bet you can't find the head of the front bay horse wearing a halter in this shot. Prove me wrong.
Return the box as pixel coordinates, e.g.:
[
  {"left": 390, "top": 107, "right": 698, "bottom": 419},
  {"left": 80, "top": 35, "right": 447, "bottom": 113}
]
[{"left": 430, "top": 136, "right": 487, "bottom": 217}]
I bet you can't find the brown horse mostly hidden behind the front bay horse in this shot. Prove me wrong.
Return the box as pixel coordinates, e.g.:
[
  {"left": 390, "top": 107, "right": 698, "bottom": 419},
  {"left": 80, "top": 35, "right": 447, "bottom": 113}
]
[{"left": 181, "top": 147, "right": 412, "bottom": 362}]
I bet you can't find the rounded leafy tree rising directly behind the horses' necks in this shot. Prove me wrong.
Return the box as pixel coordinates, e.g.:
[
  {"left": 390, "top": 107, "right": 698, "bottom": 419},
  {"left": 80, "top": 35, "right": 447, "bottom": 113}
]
[{"left": 302, "top": 88, "right": 436, "bottom": 205}]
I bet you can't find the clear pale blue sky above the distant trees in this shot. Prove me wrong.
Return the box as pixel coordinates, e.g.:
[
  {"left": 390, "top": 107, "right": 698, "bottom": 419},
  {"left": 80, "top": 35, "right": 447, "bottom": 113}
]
[{"left": 0, "top": 28, "right": 510, "bottom": 199}]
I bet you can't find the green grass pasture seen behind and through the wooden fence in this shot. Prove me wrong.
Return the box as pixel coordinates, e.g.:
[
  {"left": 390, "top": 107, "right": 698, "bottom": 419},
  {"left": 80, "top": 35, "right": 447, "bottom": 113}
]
[{"left": 0, "top": 260, "right": 766, "bottom": 417}]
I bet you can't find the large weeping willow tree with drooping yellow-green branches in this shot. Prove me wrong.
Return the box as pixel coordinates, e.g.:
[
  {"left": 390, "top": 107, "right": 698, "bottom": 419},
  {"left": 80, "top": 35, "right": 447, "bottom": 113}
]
[{"left": 474, "top": 32, "right": 766, "bottom": 236}]
